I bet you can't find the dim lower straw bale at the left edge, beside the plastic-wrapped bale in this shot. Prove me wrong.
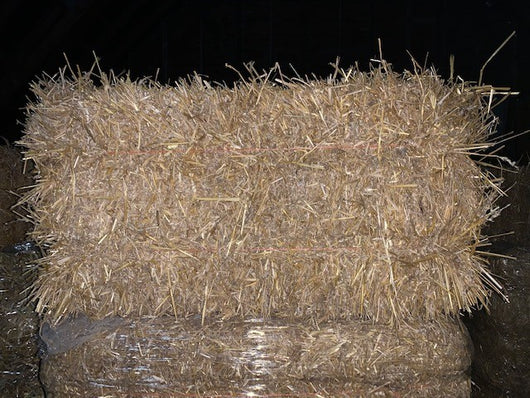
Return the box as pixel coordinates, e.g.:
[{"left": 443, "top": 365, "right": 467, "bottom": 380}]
[{"left": 0, "top": 253, "right": 42, "bottom": 397}]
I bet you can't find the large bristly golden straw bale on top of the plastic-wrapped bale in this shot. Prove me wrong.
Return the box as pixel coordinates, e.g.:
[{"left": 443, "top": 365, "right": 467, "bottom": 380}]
[{"left": 21, "top": 62, "right": 504, "bottom": 320}]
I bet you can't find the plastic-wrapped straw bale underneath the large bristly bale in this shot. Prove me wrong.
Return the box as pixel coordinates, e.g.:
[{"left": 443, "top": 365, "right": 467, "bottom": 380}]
[{"left": 41, "top": 317, "right": 471, "bottom": 397}]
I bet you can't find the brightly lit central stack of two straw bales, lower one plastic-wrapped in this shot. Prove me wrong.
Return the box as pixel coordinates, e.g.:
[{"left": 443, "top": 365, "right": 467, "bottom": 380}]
[{"left": 20, "top": 62, "right": 501, "bottom": 397}]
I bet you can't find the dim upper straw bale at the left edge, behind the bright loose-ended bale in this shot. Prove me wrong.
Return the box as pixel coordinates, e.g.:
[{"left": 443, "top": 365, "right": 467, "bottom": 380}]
[{"left": 0, "top": 145, "right": 32, "bottom": 249}]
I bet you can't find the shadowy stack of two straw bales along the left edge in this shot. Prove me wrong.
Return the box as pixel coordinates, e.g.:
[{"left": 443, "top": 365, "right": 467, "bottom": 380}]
[{"left": 0, "top": 145, "right": 42, "bottom": 397}]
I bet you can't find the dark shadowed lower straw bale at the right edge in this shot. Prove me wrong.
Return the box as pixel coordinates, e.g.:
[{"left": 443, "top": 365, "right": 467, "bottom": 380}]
[{"left": 466, "top": 247, "right": 530, "bottom": 397}]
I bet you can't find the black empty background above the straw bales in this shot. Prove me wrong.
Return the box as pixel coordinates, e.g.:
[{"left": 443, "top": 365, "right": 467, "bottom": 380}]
[{"left": 0, "top": 0, "right": 530, "bottom": 162}]
